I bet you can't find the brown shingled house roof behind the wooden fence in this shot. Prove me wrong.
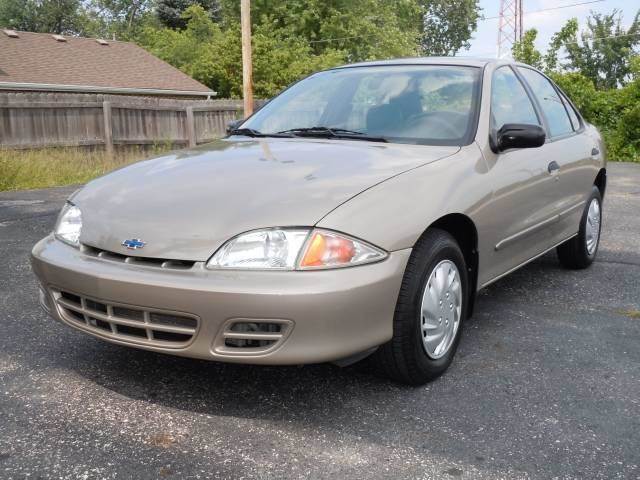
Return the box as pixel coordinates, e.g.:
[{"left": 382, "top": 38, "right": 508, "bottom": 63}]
[{"left": 0, "top": 30, "right": 215, "bottom": 96}]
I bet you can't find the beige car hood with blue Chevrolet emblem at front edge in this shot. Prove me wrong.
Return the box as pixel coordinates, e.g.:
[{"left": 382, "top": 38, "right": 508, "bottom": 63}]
[{"left": 72, "top": 138, "right": 459, "bottom": 261}]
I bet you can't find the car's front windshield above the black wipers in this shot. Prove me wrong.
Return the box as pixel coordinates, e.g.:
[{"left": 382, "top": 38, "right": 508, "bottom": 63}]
[{"left": 237, "top": 65, "right": 480, "bottom": 145}]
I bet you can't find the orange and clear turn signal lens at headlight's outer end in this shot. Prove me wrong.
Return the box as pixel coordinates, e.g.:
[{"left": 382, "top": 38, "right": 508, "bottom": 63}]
[{"left": 299, "top": 230, "right": 386, "bottom": 269}]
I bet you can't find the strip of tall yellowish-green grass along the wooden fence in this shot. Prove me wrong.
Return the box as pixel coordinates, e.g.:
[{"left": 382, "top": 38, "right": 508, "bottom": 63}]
[{"left": 0, "top": 146, "right": 169, "bottom": 191}]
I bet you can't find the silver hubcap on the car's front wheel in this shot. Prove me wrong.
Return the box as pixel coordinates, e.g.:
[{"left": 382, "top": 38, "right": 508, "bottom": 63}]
[{"left": 420, "top": 260, "right": 462, "bottom": 359}]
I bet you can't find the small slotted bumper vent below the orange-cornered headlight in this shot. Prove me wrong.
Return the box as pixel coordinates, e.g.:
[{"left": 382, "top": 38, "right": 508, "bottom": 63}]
[{"left": 215, "top": 319, "right": 293, "bottom": 355}]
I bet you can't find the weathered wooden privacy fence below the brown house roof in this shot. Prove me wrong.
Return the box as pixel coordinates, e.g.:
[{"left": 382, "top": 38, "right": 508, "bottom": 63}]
[{"left": 0, "top": 93, "right": 264, "bottom": 152}]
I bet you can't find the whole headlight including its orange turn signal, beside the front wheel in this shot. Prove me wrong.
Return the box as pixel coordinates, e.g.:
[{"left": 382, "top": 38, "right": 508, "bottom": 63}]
[{"left": 207, "top": 228, "right": 387, "bottom": 270}]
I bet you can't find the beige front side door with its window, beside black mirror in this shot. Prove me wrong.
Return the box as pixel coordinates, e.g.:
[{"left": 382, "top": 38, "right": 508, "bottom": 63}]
[{"left": 481, "top": 66, "right": 557, "bottom": 283}]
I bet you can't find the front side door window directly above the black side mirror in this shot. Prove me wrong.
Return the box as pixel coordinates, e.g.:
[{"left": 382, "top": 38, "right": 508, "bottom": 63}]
[{"left": 491, "top": 67, "right": 540, "bottom": 130}]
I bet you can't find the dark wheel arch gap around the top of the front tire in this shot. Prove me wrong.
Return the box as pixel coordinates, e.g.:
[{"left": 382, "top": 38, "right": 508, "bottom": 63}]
[{"left": 423, "top": 213, "right": 479, "bottom": 317}]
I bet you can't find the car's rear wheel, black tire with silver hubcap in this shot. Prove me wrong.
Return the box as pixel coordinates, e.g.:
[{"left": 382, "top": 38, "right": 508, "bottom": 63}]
[{"left": 556, "top": 186, "right": 602, "bottom": 270}]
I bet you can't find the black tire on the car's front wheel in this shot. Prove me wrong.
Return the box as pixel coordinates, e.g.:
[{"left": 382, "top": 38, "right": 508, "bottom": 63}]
[{"left": 374, "top": 228, "right": 469, "bottom": 385}]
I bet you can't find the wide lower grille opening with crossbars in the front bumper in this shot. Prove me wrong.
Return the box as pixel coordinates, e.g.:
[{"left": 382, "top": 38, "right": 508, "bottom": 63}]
[{"left": 53, "top": 290, "right": 198, "bottom": 348}]
